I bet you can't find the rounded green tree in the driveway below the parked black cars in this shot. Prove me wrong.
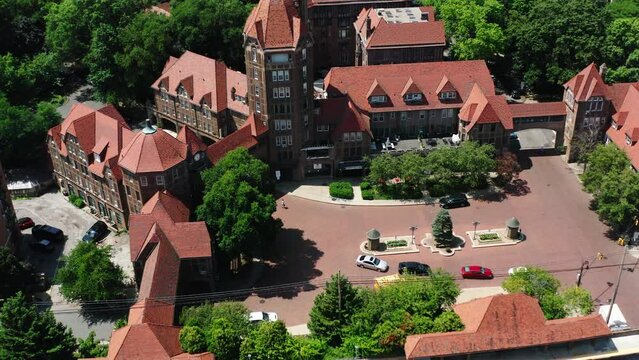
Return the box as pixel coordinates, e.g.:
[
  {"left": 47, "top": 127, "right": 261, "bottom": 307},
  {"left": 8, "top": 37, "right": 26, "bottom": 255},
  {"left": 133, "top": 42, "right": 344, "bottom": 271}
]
[{"left": 56, "top": 241, "right": 124, "bottom": 301}]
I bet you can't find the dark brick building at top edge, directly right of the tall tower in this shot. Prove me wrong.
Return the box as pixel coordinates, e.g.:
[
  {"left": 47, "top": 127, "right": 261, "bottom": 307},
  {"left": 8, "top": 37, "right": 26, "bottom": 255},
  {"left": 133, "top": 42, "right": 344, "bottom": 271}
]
[{"left": 302, "top": 0, "right": 413, "bottom": 70}]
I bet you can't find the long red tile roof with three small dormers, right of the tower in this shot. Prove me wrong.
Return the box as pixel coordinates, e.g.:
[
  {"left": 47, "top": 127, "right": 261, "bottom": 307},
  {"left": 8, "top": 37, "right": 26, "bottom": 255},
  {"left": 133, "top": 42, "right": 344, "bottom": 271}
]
[{"left": 324, "top": 60, "right": 495, "bottom": 112}]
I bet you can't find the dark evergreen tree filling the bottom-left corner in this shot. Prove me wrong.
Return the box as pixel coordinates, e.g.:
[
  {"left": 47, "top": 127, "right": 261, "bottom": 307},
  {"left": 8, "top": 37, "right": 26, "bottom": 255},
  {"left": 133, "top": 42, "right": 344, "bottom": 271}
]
[{"left": 0, "top": 293, "right": 76, "bottom": 360}]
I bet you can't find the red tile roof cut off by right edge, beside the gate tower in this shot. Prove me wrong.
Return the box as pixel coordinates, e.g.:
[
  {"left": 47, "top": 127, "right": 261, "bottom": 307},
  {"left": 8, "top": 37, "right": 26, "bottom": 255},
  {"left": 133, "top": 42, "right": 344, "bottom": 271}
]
[{"left": 606, "top": 86, "right": 639, "bottom": 169}]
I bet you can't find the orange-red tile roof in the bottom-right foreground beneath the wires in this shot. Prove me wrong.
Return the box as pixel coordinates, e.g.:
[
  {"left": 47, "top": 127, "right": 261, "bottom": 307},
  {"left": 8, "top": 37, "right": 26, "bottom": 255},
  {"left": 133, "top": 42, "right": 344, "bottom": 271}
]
[{"left": 404, "top": 294, "right": 610, "bottom": 359}]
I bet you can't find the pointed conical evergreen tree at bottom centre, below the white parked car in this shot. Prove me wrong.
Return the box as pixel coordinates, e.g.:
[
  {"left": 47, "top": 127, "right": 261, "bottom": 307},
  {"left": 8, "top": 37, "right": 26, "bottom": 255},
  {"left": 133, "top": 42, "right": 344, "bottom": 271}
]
[{"left": 308, "top": 273, "right": 362, "bottom": 346}]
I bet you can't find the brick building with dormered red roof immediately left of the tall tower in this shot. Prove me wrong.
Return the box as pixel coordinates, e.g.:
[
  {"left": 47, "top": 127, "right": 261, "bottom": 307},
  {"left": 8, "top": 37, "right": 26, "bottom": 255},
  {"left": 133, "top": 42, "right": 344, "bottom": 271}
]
[{"left": 151, "top": 51, "right": 248, "bottom": 144}]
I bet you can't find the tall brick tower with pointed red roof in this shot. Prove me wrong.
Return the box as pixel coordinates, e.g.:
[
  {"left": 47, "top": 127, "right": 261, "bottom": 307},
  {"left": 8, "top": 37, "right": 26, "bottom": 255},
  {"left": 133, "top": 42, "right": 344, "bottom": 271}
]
[{"left": 244, "top": 0, "right": 313, "bottom": 179}]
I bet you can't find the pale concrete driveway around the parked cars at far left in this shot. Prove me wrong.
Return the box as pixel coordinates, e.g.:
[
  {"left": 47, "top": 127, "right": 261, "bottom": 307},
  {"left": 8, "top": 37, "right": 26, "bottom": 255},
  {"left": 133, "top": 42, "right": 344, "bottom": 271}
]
[{"left": 13, "top": 192, "right": 133, "bottom": 339}]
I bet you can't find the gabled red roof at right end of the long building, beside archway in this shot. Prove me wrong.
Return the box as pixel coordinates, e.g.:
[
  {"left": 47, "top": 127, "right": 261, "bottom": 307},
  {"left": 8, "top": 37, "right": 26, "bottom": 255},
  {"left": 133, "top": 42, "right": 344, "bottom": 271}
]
[{"left": 459, "top": 85, "right": 513, "bottom": 131}]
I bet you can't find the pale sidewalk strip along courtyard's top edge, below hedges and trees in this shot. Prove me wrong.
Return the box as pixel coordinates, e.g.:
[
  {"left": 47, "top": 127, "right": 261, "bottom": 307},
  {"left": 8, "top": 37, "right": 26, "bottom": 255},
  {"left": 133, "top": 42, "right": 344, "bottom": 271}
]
[{"left": 276, "top": 179, "right": 502, "bottom": 206}]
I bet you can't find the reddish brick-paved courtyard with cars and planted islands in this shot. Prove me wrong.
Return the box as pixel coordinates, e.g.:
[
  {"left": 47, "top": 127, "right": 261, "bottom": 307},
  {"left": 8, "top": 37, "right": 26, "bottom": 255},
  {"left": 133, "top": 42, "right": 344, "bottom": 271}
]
[{"left": 240, "top": 153, "right": 639, "bottom": 327}]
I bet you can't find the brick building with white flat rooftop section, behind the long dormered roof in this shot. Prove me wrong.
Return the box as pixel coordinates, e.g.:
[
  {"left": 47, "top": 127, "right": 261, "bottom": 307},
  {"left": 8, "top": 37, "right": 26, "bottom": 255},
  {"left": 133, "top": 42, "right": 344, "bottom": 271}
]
[{"left": 353, "top": 6, "right": 446, "bottom": 65}]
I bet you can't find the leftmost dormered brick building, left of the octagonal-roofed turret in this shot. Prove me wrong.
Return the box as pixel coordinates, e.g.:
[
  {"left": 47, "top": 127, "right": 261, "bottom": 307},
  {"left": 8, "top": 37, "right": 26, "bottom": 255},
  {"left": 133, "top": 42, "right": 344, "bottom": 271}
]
[{"left": 47, "top": 104, "right": 134, "bottom": 228}]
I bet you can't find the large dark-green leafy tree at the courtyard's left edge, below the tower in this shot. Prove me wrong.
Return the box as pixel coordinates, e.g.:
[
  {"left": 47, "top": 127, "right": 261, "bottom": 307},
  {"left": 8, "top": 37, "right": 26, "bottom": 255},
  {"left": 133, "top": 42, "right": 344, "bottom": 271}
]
[{"left": 196, "top": 148, "right": 279, "bottom": 256}]
